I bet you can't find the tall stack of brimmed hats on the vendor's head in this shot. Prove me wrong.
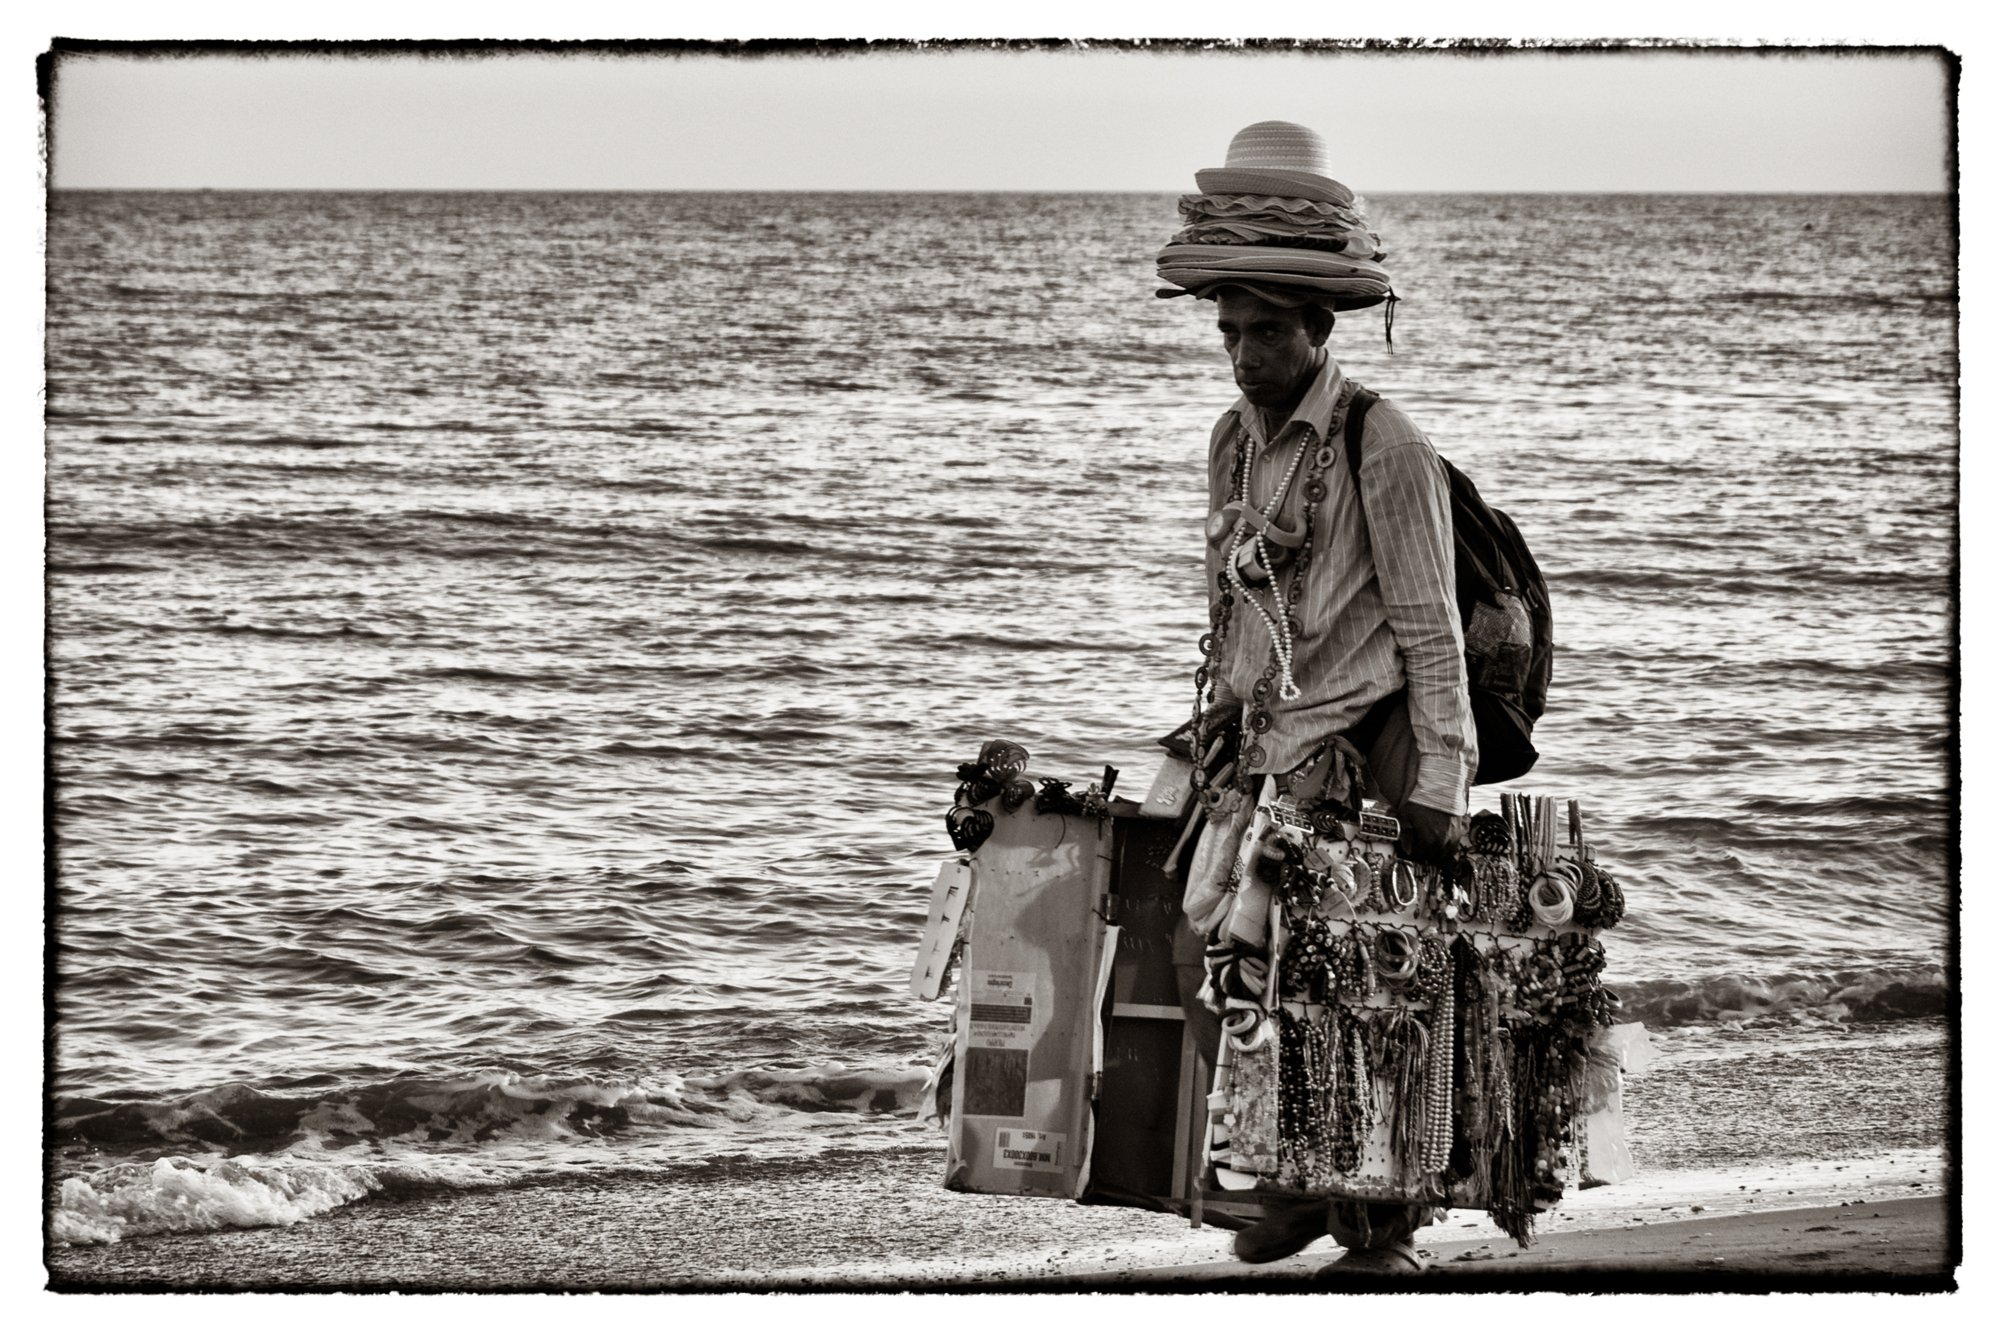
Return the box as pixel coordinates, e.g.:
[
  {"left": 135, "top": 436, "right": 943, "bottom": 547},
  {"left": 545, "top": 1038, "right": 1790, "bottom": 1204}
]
[{"left": 1158, "top": 120, "right": 1396, "bottom": 310}]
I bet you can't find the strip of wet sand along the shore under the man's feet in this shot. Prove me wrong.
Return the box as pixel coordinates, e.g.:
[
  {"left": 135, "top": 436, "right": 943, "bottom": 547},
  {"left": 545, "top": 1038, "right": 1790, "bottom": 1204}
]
[{"left": 48, "top": 1152, "right": 1956, "bottom": 1292}]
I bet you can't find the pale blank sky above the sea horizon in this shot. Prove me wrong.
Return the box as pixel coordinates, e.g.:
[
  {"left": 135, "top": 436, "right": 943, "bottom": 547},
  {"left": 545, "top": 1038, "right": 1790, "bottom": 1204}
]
[{"left": 50, "top": 48, "right": 1950, "bottom": 192}]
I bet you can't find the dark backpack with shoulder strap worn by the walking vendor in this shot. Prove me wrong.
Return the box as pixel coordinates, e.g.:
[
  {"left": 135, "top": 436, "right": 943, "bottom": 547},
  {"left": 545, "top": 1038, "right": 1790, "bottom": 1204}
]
[{"left": 1346, "top": 388, "right": 1556, "bottom": 784}]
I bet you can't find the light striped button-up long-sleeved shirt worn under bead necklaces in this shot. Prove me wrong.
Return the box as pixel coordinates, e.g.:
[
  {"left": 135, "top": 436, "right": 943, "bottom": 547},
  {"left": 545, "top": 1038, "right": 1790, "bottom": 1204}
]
[{"left": 1208, "top": 352, "right": 1478, "bottom": 816}]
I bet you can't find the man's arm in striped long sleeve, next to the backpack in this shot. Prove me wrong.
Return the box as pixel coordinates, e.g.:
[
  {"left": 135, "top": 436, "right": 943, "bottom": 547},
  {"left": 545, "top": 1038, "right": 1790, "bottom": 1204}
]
[{"left": 1362, "top": 402, "right": 1478, "bottom": 816}]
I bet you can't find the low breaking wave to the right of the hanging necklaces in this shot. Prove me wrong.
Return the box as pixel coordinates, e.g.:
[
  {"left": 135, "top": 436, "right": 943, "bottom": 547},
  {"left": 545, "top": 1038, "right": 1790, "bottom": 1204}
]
[{"left": 1608, "top": 964, "right": 1958, "bottom": 1028}]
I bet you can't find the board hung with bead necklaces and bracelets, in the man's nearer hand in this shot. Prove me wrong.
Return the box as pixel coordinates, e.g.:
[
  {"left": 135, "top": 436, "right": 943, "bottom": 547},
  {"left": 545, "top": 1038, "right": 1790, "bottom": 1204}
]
[{"left": 1212, "top": 796, "right": 1616, "bottom": 1240}]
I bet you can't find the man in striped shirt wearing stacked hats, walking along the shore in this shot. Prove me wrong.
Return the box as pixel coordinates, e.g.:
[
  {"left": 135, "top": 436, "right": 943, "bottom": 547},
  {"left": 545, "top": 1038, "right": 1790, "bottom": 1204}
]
[{"left": 1160, "top": 122, "right": 1478, "bottom": 1272}]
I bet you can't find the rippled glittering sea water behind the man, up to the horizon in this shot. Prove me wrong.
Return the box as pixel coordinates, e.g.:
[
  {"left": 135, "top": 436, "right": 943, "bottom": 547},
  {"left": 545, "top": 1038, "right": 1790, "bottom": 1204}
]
[{"left": 46, "top": 192, "right": 1958, "bottom": 1242}]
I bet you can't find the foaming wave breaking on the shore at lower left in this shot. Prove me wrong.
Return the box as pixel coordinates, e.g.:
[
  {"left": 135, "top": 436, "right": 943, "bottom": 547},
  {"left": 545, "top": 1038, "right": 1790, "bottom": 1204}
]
[{"left": 48, "top": 1068, "right": 924, "bottom": 1244}]
